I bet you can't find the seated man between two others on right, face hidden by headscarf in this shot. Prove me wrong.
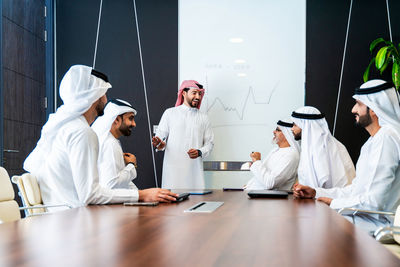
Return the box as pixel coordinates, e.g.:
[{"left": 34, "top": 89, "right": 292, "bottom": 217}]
[{"left": 292, "top": 106, "right": 355, "bottom": 188}]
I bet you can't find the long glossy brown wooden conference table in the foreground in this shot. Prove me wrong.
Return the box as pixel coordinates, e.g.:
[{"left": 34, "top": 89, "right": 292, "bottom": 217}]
[{"left": 0, "top": 190, "right": 400, "bottom": 266}]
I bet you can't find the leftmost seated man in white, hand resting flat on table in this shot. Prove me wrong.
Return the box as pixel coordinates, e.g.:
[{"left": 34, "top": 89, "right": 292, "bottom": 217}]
[{"left": 24, "top": 65, "right": 176, "bottom": 207}]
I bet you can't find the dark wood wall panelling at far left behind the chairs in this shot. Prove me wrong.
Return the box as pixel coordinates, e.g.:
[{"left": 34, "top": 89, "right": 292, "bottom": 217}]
[{"left": 1, "top": 0, "right": 46, "bottom": 214}]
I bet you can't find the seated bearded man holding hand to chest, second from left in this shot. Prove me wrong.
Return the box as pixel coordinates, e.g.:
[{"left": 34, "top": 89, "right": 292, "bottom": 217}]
[{"left": 92, "top": 99, "right": 137, "bottom": 190}]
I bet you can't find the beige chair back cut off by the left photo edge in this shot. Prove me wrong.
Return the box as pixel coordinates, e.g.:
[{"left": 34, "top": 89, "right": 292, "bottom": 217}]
[{"left": 0, "top": 167, "right": 21, "bottom": 223}]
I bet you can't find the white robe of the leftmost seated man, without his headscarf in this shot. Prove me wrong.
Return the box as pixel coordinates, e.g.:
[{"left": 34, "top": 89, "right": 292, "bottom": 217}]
[{"left": 36, "top": 116, "right": 139, "bottom": 210}]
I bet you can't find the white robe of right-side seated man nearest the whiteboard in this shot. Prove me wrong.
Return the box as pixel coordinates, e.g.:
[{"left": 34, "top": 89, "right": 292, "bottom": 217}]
[{"left": 245, "top": 147, "right": 300, "bottom": 190}]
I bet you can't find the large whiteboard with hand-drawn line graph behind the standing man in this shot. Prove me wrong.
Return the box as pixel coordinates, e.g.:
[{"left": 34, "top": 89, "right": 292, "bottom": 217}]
[{"left": 178, "top": 0, "right": 306, "bottom": 188}]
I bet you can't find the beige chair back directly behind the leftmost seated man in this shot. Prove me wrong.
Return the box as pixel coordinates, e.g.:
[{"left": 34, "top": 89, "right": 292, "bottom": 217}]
[{"left": 12, "top": 173, "right": 46, "bottom": 215}]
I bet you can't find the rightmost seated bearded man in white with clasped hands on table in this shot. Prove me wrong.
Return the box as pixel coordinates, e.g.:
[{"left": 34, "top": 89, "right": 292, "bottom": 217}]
[{"left": 294, "top": 80, "right": 400, "bottom": 231}]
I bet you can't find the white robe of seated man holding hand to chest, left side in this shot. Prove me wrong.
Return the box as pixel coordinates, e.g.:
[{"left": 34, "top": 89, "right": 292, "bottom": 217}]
[{"left": 98, "top": 132, "right": 137, "bottom": 190}]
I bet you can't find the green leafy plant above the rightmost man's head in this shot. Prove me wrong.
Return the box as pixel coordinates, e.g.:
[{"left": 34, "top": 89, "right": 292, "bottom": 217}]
[{"left": 363, "top": 38, "right": 400, "bottom": 90}]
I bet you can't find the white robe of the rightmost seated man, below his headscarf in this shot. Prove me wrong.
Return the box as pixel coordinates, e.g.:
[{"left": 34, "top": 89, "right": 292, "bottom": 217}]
[{"left": 316, "top": 126, "right": 400, "bottom": 233}]
